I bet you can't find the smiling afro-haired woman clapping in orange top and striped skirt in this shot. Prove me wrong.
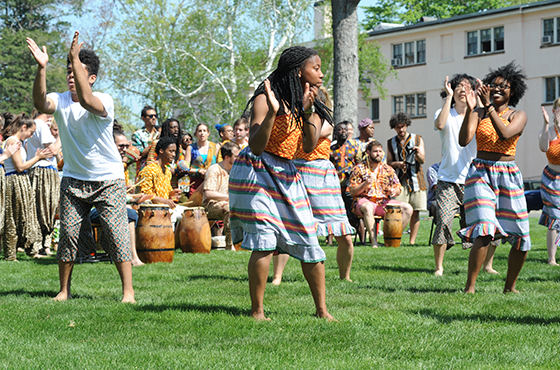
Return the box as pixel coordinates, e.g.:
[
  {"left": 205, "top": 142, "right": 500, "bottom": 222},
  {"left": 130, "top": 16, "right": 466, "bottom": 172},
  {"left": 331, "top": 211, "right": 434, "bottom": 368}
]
[{"left": 458, "top": 62, "right": 531, "bottom": 293}]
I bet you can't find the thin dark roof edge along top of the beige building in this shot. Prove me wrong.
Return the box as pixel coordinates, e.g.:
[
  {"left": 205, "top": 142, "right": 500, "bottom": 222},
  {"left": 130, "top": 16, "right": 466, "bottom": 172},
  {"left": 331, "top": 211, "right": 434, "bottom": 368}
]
[{"left": 367, "top": 0, "right": 560, "bottom": 36}]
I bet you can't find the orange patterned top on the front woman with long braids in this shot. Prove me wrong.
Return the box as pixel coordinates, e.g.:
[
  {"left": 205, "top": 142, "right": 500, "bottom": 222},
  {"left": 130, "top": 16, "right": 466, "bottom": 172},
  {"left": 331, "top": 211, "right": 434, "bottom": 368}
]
[{"left": 264, "top": 114, "right": 301, "bottom": 159}]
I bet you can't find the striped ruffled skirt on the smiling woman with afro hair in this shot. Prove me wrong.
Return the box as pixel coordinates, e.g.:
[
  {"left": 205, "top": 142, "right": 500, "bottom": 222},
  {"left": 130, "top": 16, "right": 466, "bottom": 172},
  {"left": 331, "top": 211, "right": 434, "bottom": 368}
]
[{"left": 457, "top": 158, "right": 531, "bottom": 252}]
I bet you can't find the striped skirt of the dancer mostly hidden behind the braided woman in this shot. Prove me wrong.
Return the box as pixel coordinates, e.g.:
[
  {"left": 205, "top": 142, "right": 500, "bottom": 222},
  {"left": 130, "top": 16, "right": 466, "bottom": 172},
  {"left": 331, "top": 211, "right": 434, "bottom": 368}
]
[{"left": 294, "top": 159, "right": 355, "bottom": 236}]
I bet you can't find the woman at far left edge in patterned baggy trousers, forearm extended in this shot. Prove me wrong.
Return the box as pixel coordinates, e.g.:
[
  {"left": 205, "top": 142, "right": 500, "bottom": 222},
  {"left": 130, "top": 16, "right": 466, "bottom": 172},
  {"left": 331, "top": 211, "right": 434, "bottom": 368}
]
[{"left": 2, "top": 113, "right": 52, "bottom": 261}]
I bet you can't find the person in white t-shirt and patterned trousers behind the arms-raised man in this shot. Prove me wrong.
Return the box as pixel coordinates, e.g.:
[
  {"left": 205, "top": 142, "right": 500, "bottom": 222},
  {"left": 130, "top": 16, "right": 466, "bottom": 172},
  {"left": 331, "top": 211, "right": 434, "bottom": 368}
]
[{"left": 26, "top": 113, "right": 60, "bottom": 255}]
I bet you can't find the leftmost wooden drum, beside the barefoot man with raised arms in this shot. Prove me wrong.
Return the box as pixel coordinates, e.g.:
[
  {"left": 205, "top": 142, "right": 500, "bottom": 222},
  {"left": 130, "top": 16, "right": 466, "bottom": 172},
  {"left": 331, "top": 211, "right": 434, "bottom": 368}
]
[{"left": 136, "top": 204, "right": 175, "bottom": 263}]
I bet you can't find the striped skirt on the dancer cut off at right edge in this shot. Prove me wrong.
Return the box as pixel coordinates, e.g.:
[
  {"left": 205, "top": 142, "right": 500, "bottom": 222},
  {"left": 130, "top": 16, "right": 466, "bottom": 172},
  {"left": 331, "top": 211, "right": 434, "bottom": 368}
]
[{"left": 539, "top": 166, "right": 560, "bottom": 245}]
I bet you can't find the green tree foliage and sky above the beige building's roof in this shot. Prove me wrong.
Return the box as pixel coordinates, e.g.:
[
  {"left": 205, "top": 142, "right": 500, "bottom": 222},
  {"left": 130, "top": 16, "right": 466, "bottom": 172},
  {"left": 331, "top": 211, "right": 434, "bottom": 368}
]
[{"left": 362, "top": 0, "right": 536, "bottom": 30}]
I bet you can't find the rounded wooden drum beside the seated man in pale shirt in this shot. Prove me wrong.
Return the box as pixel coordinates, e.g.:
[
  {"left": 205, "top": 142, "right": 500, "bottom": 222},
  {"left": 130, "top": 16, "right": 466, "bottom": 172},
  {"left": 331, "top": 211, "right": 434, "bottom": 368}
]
[{"left": 175, "top": 207, "right": 212, "bottom": 253}]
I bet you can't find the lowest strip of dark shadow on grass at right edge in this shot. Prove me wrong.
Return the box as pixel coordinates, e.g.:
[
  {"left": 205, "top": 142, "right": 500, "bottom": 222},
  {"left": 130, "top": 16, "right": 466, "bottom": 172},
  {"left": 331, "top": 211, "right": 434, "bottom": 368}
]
[{"left": 408, "top": 309, "right": 560, "bottom": 325}]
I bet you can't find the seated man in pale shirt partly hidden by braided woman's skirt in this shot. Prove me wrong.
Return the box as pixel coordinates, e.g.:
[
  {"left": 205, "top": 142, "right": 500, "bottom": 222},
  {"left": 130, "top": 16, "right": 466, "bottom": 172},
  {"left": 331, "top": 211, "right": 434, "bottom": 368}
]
[{"left": 202, "top": 141, "right": 240, "bottom": 250}]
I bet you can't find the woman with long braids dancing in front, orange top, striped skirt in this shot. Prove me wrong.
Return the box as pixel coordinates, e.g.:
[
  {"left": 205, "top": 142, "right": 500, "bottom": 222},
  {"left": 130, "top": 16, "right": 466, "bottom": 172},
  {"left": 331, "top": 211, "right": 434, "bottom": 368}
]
[{"left": 229, "top": 46, "right": 333, "bottom": 320}]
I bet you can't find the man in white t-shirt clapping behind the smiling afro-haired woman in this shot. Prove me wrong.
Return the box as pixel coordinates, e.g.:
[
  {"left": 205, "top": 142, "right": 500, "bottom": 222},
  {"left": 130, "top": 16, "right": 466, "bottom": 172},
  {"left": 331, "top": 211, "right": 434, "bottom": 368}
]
[{"left": 432, "top": 74, "right": 496, "bottom": 276}]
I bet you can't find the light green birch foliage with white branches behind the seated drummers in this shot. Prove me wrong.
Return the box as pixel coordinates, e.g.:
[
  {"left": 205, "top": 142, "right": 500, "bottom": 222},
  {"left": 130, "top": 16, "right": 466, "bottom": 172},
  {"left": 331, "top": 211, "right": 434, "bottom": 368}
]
[{"left": 104, "top": 0, "right": 313, "bottom": 128}]
